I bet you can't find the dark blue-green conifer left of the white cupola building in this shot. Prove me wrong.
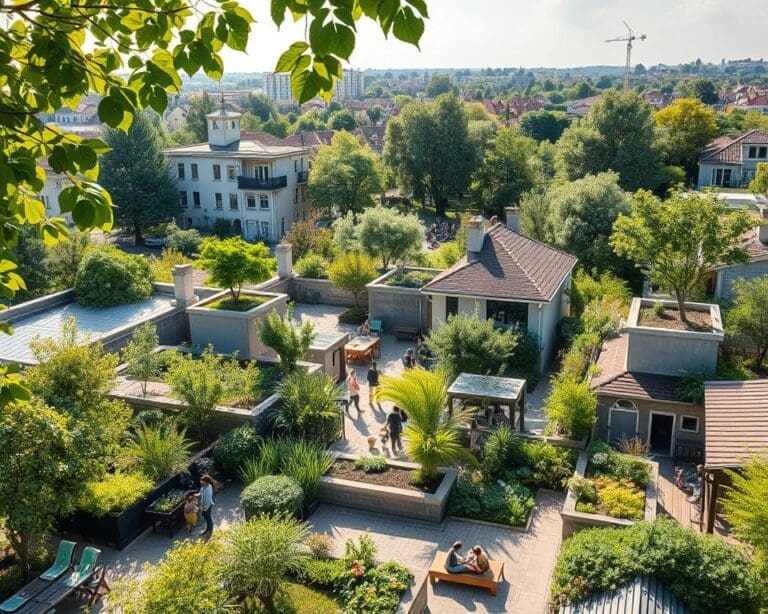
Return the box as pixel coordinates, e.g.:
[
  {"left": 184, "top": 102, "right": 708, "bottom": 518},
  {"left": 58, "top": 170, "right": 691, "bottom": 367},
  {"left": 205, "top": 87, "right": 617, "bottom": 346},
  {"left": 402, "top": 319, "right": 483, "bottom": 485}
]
[{"left": 99, "top": 113, "right": 181, "bottom": 245}]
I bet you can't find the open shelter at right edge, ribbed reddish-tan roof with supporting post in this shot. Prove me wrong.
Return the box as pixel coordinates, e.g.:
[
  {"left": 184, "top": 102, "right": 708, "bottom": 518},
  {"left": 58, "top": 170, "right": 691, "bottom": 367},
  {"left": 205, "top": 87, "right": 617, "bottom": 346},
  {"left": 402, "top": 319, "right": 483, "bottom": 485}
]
[{"left": 699, "top": 380, "right": 768, "bottom": 533}]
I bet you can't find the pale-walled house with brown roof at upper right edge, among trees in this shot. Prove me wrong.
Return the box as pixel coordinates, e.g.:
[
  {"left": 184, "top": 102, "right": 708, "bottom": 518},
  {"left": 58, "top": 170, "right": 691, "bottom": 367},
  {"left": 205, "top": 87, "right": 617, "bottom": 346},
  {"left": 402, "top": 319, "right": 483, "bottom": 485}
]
[{"left": 698, "top": 130, "right": 768, "bottom": 189}]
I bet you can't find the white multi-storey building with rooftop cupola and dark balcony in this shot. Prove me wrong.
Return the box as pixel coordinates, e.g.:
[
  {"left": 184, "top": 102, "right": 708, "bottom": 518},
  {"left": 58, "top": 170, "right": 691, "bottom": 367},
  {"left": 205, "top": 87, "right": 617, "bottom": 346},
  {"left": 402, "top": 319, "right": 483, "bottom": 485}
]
[{"left": 164, "top": 110, "right": 310, "bottom": 243}]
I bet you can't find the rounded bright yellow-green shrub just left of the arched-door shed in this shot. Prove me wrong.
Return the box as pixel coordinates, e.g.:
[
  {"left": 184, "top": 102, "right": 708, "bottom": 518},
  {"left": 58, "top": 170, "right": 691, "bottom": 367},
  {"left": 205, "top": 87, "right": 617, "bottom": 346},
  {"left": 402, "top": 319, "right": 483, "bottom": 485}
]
[{"left": 544, "top": 378, "right": 597, "bottom": 439}]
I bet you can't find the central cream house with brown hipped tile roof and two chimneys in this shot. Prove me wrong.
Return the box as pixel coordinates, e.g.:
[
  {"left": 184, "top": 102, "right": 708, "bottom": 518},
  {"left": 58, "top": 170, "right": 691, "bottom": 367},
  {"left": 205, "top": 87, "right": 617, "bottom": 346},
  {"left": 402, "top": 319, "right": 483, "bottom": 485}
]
[{"left": 421, "top": 207, "right": 576, "bottom": 371}]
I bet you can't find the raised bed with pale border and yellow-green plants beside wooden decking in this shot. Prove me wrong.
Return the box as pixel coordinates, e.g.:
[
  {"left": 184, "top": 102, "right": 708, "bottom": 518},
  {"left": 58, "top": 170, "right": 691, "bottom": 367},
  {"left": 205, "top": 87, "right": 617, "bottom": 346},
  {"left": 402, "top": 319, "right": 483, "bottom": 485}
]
[{"left": 560, "top": 451, "right": 659, "bottom": 539}]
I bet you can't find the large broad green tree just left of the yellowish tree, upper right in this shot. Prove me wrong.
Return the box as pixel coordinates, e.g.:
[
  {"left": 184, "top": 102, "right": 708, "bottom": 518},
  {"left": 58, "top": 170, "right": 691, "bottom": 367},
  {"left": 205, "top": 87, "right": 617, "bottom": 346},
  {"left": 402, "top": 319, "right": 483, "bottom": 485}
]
[{"left": 557, "top": 92, "right": 663, "bottom": 192}]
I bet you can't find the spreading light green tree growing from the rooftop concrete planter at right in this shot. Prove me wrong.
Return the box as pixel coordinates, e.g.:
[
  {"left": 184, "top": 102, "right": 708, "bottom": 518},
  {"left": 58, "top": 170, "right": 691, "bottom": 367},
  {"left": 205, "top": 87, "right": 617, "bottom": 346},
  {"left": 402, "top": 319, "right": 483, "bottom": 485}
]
[{"left": 611, "top": 191, "right": 753, "bottom": 323}]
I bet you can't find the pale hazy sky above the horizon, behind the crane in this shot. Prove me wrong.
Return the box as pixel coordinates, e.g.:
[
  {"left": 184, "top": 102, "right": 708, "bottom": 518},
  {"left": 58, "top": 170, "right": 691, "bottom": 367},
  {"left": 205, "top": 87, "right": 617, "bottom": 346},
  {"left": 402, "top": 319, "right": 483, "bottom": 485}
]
[{"left": 219, "top": 0, "right": 768, "bottom": 72}]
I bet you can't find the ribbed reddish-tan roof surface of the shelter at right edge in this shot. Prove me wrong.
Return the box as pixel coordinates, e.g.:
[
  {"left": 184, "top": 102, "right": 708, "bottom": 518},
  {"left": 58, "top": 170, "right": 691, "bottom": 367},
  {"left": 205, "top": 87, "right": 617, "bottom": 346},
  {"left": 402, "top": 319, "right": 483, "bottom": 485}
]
[{"left": 704, "top": 380, "right": 768, "bottom": 467}]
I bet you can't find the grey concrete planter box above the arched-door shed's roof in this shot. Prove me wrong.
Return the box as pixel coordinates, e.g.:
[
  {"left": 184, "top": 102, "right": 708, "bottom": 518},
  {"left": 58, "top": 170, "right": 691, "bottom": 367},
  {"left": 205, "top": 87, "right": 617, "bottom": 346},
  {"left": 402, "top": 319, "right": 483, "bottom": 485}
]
[{"left": 624, "top": 298, "right": 725, "bottom": 377}]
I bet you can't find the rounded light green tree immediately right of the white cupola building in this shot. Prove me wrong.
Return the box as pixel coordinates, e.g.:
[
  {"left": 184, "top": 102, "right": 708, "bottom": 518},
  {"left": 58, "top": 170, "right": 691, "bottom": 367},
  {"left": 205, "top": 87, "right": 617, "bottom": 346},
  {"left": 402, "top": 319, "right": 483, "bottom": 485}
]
[{"left": 307, "top": 132, "right": 381, "bottom": 215}]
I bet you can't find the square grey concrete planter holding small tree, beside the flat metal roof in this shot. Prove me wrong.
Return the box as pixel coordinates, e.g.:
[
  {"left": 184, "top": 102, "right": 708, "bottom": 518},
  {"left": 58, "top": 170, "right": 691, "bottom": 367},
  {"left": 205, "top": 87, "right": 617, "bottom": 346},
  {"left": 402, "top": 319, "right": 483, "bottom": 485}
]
[{"left": 186, "top": 291, "right": 288, "bottom": 358}]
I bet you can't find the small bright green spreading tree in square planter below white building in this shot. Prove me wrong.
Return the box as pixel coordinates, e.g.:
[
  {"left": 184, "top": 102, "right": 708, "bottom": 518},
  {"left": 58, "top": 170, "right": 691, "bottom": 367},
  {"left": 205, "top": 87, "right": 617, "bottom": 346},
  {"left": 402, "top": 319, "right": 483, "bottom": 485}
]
[{"left": 198, "top": 237, "right": 275, "bottom": 303}]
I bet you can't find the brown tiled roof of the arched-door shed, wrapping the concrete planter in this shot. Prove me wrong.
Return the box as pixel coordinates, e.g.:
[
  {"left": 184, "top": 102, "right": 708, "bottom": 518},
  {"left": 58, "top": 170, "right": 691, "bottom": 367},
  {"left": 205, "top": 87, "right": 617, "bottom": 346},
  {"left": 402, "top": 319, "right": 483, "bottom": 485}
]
[{"left": 590, "top": 334, "right": 689, "bottom": 403}]
